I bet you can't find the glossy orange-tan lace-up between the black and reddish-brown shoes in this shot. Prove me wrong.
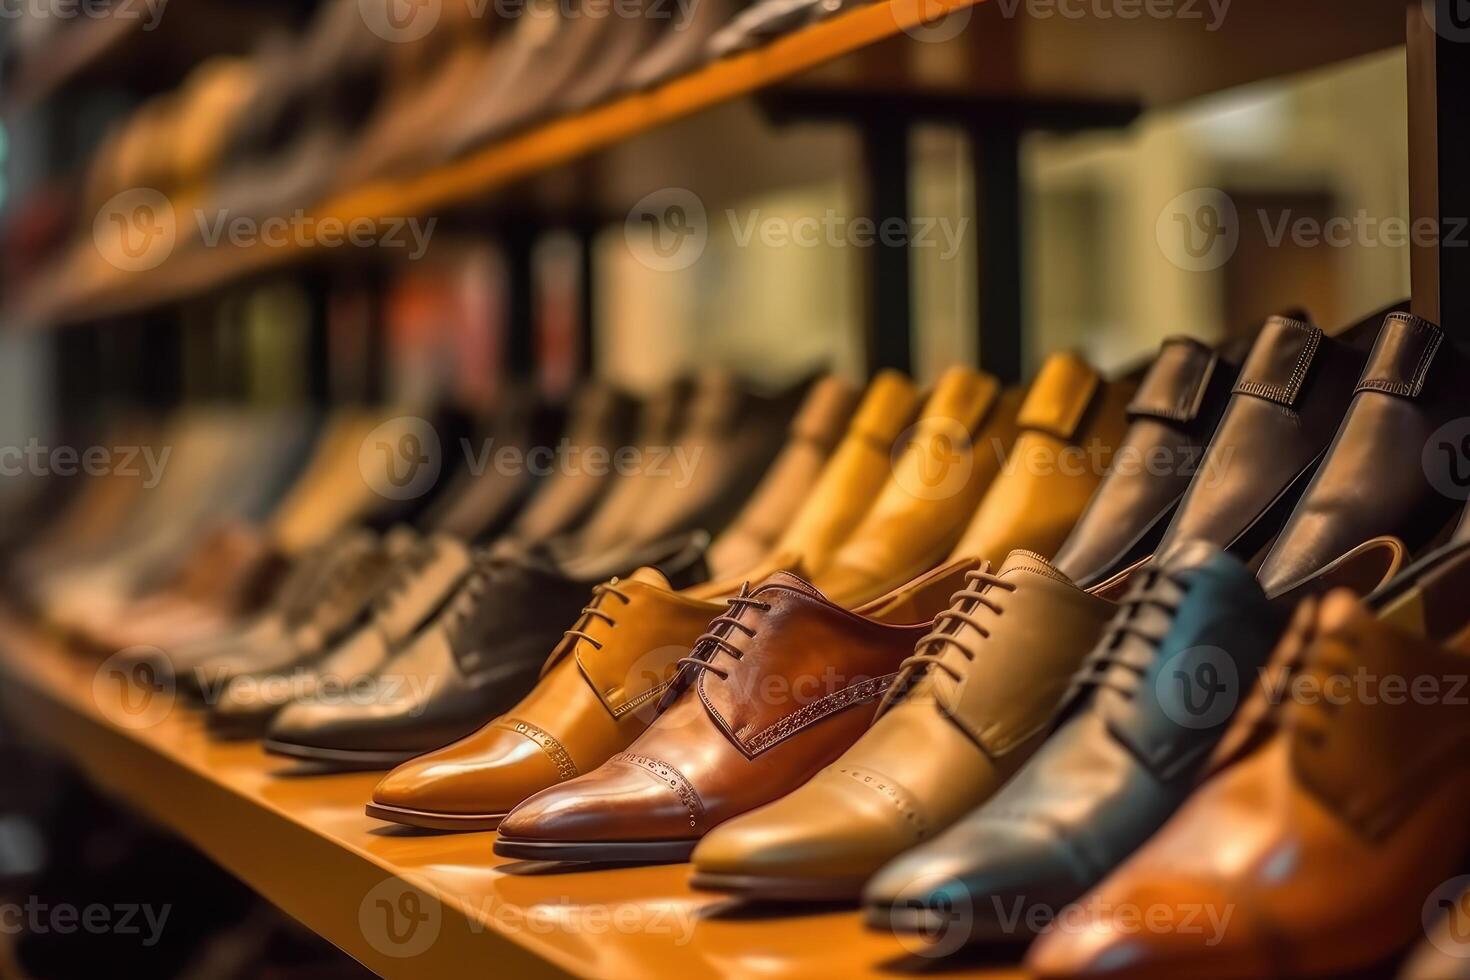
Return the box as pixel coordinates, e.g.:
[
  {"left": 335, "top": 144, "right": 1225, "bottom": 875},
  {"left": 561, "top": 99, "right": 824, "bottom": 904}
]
[{"left": 373, "top": 569, "right": 723, "bottom": 820}]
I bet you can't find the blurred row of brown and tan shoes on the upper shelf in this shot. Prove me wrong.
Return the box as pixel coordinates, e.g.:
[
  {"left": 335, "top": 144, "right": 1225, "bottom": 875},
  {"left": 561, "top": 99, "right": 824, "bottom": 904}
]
[{"left": 77, "top": 0, "right": 870, "bottom": 228}]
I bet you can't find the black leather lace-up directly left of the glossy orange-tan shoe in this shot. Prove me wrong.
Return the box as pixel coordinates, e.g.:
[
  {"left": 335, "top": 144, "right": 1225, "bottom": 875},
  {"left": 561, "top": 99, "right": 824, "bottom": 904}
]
[{"left": 265, "top": 533, "right": 709, "bottom": 768}]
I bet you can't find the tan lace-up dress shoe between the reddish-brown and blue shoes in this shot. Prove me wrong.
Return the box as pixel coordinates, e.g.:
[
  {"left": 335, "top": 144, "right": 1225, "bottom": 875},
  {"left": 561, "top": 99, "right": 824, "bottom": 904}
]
[{"left": 694, "top": 551, "right": 1114, "bottom": 901}]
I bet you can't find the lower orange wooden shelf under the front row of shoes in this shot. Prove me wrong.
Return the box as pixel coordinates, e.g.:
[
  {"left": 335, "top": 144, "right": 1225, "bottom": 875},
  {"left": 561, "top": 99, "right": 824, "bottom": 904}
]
[{"left": 0, "top": 616, "right": 1020, "bottom": 980}]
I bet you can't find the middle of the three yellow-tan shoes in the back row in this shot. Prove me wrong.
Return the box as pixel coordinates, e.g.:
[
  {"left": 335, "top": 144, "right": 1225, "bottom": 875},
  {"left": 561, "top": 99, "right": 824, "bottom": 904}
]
[{"left": 813, "top": 367, "right": 1020, "bottom": 607}]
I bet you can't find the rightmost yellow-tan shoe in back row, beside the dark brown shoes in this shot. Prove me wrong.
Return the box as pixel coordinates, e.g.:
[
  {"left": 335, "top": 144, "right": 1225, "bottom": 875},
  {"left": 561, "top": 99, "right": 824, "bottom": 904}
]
[{"left": 951, "top": 354, "right": 1133, "bottom": 561}]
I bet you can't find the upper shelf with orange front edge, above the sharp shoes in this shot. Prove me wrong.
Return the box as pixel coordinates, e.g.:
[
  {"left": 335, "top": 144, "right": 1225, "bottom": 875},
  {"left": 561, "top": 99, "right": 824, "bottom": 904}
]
[{"left": 4, "top": 0, "right": 1414, "bottom": 325}]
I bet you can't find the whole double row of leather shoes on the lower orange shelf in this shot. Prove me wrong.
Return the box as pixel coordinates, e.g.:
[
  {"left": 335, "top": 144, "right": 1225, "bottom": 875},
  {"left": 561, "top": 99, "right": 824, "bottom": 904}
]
[{"left": 7, "top": 309, "right": 1470, "bottom": 977}]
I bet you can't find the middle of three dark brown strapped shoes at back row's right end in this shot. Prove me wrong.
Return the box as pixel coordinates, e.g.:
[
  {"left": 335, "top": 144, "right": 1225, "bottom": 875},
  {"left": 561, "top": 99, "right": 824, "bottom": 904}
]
[{"left": 1155, "top": 316, "right": 1366, "bottom": 567}]
